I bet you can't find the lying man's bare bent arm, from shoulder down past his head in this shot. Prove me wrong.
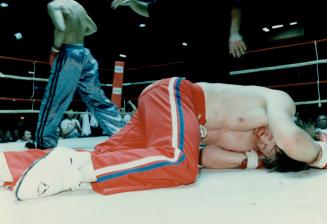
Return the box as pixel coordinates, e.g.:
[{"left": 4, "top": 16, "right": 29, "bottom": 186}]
[{"left": 267, "top": 91, "right": 319, "bottom": 164}]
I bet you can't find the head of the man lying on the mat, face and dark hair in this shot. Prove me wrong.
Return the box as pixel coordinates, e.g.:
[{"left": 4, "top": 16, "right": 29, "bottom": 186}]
[{"left": 255, "top": 127, "right": 309, "bottom": 172}]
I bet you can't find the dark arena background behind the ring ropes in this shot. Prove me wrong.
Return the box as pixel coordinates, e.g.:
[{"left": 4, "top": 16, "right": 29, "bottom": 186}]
[{"left": 0, "top": 0, "right": 327, "bottom": 131}]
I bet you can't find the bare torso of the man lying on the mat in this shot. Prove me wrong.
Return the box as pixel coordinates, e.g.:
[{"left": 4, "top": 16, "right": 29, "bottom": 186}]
[{"left": 197, "top": 83, "right": 294, "bottom": 152}]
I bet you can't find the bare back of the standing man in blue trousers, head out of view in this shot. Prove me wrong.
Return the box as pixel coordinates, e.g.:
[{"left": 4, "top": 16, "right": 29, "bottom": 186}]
[{"left": 48, "top": 0, "right": 97, "bottom": 48}]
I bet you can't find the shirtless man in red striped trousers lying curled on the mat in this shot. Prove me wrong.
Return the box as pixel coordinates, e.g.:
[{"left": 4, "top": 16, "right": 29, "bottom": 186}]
[{"left": 0, "top": 77, "right": 327, "bottom": 200}]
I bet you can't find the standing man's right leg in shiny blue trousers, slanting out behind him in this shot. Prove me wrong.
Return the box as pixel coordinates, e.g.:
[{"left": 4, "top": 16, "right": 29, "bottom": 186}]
[{"left": 77, "top": 49, "right": 125, "bottom": 136}]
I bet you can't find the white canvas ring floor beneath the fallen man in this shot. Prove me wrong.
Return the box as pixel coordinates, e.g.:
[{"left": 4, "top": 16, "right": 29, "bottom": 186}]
[{"left": 0, "top": 137, "right": 327, "bottom": 224}]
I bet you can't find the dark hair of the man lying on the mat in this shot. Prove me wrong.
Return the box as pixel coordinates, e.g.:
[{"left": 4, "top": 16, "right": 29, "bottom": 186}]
[{"left": 263, "top": 146, "right": 310, "bottom": 172}]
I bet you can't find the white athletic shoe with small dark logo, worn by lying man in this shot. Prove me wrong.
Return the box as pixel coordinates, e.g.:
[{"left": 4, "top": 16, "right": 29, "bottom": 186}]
[{"left": 14, "top": 147, "right": 90, "bottom": 200}]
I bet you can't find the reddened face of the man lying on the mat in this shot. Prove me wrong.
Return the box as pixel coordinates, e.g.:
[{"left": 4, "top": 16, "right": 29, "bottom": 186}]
[{"left": 255, "top": 127, "right": 276, "bottom": 158}]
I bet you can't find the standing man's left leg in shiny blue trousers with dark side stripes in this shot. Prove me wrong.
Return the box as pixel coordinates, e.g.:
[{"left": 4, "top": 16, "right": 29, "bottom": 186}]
[{"left": 35, "top": 45, "right": 84, "bottom": 149}]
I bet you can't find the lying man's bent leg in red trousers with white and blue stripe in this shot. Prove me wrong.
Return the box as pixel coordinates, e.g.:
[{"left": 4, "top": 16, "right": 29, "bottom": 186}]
[{"left": 91, "top": 78, "right": 200, "bottom": 194}]
